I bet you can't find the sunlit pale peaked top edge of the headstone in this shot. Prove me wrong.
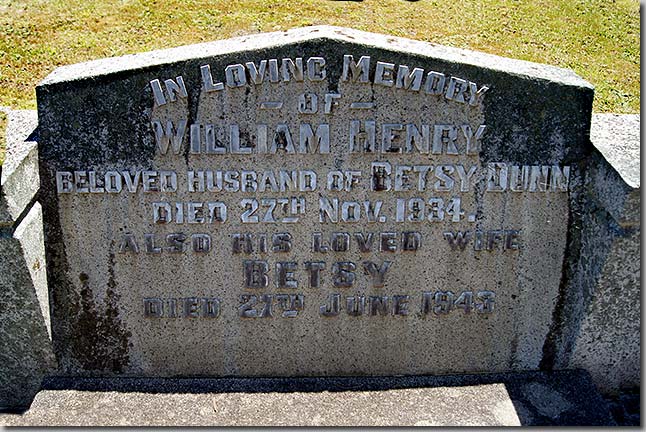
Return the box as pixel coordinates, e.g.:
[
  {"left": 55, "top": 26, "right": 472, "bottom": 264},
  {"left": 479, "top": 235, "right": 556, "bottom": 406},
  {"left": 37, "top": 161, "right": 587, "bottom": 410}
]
[{"left": 40, "top": 25, "right": 593, "bottom": 89}]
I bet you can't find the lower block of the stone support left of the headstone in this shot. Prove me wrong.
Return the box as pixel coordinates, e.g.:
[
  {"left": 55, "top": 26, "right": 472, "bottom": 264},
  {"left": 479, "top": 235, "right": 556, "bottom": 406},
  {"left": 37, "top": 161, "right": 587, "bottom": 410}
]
[{"left": 0, "top": 203, "right": 56, "bottom": 408}]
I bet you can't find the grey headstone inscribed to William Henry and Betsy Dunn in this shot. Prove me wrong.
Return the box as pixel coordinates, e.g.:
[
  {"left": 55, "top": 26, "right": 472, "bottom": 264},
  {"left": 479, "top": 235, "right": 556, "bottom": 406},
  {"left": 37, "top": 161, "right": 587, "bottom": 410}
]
[{"left": 37, "top": 27, "right": 593, "bottom": 376}]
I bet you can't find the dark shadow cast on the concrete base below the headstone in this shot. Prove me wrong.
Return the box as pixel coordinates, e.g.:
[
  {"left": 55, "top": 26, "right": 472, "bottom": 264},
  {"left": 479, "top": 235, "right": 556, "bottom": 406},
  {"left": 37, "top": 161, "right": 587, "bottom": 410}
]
[{"left": 43, "top": 370, "right": 613, "bottom": 426}]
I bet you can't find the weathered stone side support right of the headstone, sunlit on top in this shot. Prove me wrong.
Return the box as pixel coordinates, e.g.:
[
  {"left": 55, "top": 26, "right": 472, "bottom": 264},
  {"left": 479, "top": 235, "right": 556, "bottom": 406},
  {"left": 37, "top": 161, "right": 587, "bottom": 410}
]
[{"left": 566, "top": 115, "right": 641, "bottom": 394}]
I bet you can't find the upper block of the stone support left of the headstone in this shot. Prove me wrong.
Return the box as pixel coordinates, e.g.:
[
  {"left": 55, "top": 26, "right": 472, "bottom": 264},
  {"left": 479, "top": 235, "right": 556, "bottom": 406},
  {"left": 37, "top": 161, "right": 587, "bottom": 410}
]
[{"left": 0, "top": 110, "right": 40, "bottom": 226}]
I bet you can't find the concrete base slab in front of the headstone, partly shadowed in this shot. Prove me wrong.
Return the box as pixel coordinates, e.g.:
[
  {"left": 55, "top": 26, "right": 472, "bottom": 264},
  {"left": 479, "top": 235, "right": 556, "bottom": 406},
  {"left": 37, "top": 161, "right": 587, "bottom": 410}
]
[{"left": 0, "top": 371, "right": 615, "bottom": 426}]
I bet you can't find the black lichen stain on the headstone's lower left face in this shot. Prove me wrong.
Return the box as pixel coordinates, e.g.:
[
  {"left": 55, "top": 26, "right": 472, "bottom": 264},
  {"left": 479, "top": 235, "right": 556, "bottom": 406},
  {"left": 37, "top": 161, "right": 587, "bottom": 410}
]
[{"left": 71, "top": 252, "right": 132, "bottom": 373}]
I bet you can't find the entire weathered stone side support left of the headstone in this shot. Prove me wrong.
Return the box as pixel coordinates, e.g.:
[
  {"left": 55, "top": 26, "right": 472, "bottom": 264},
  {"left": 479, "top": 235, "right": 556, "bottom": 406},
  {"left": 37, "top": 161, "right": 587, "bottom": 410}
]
[{"left": 0, "top": 111, "right": 55, "bottom": 409}]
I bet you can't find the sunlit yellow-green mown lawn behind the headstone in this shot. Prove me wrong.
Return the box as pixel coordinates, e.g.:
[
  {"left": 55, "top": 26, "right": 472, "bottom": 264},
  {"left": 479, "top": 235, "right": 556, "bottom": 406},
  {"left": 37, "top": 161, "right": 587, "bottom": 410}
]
[{"left": 0, "top": 0, "right": 640, "bottom": 163}]
